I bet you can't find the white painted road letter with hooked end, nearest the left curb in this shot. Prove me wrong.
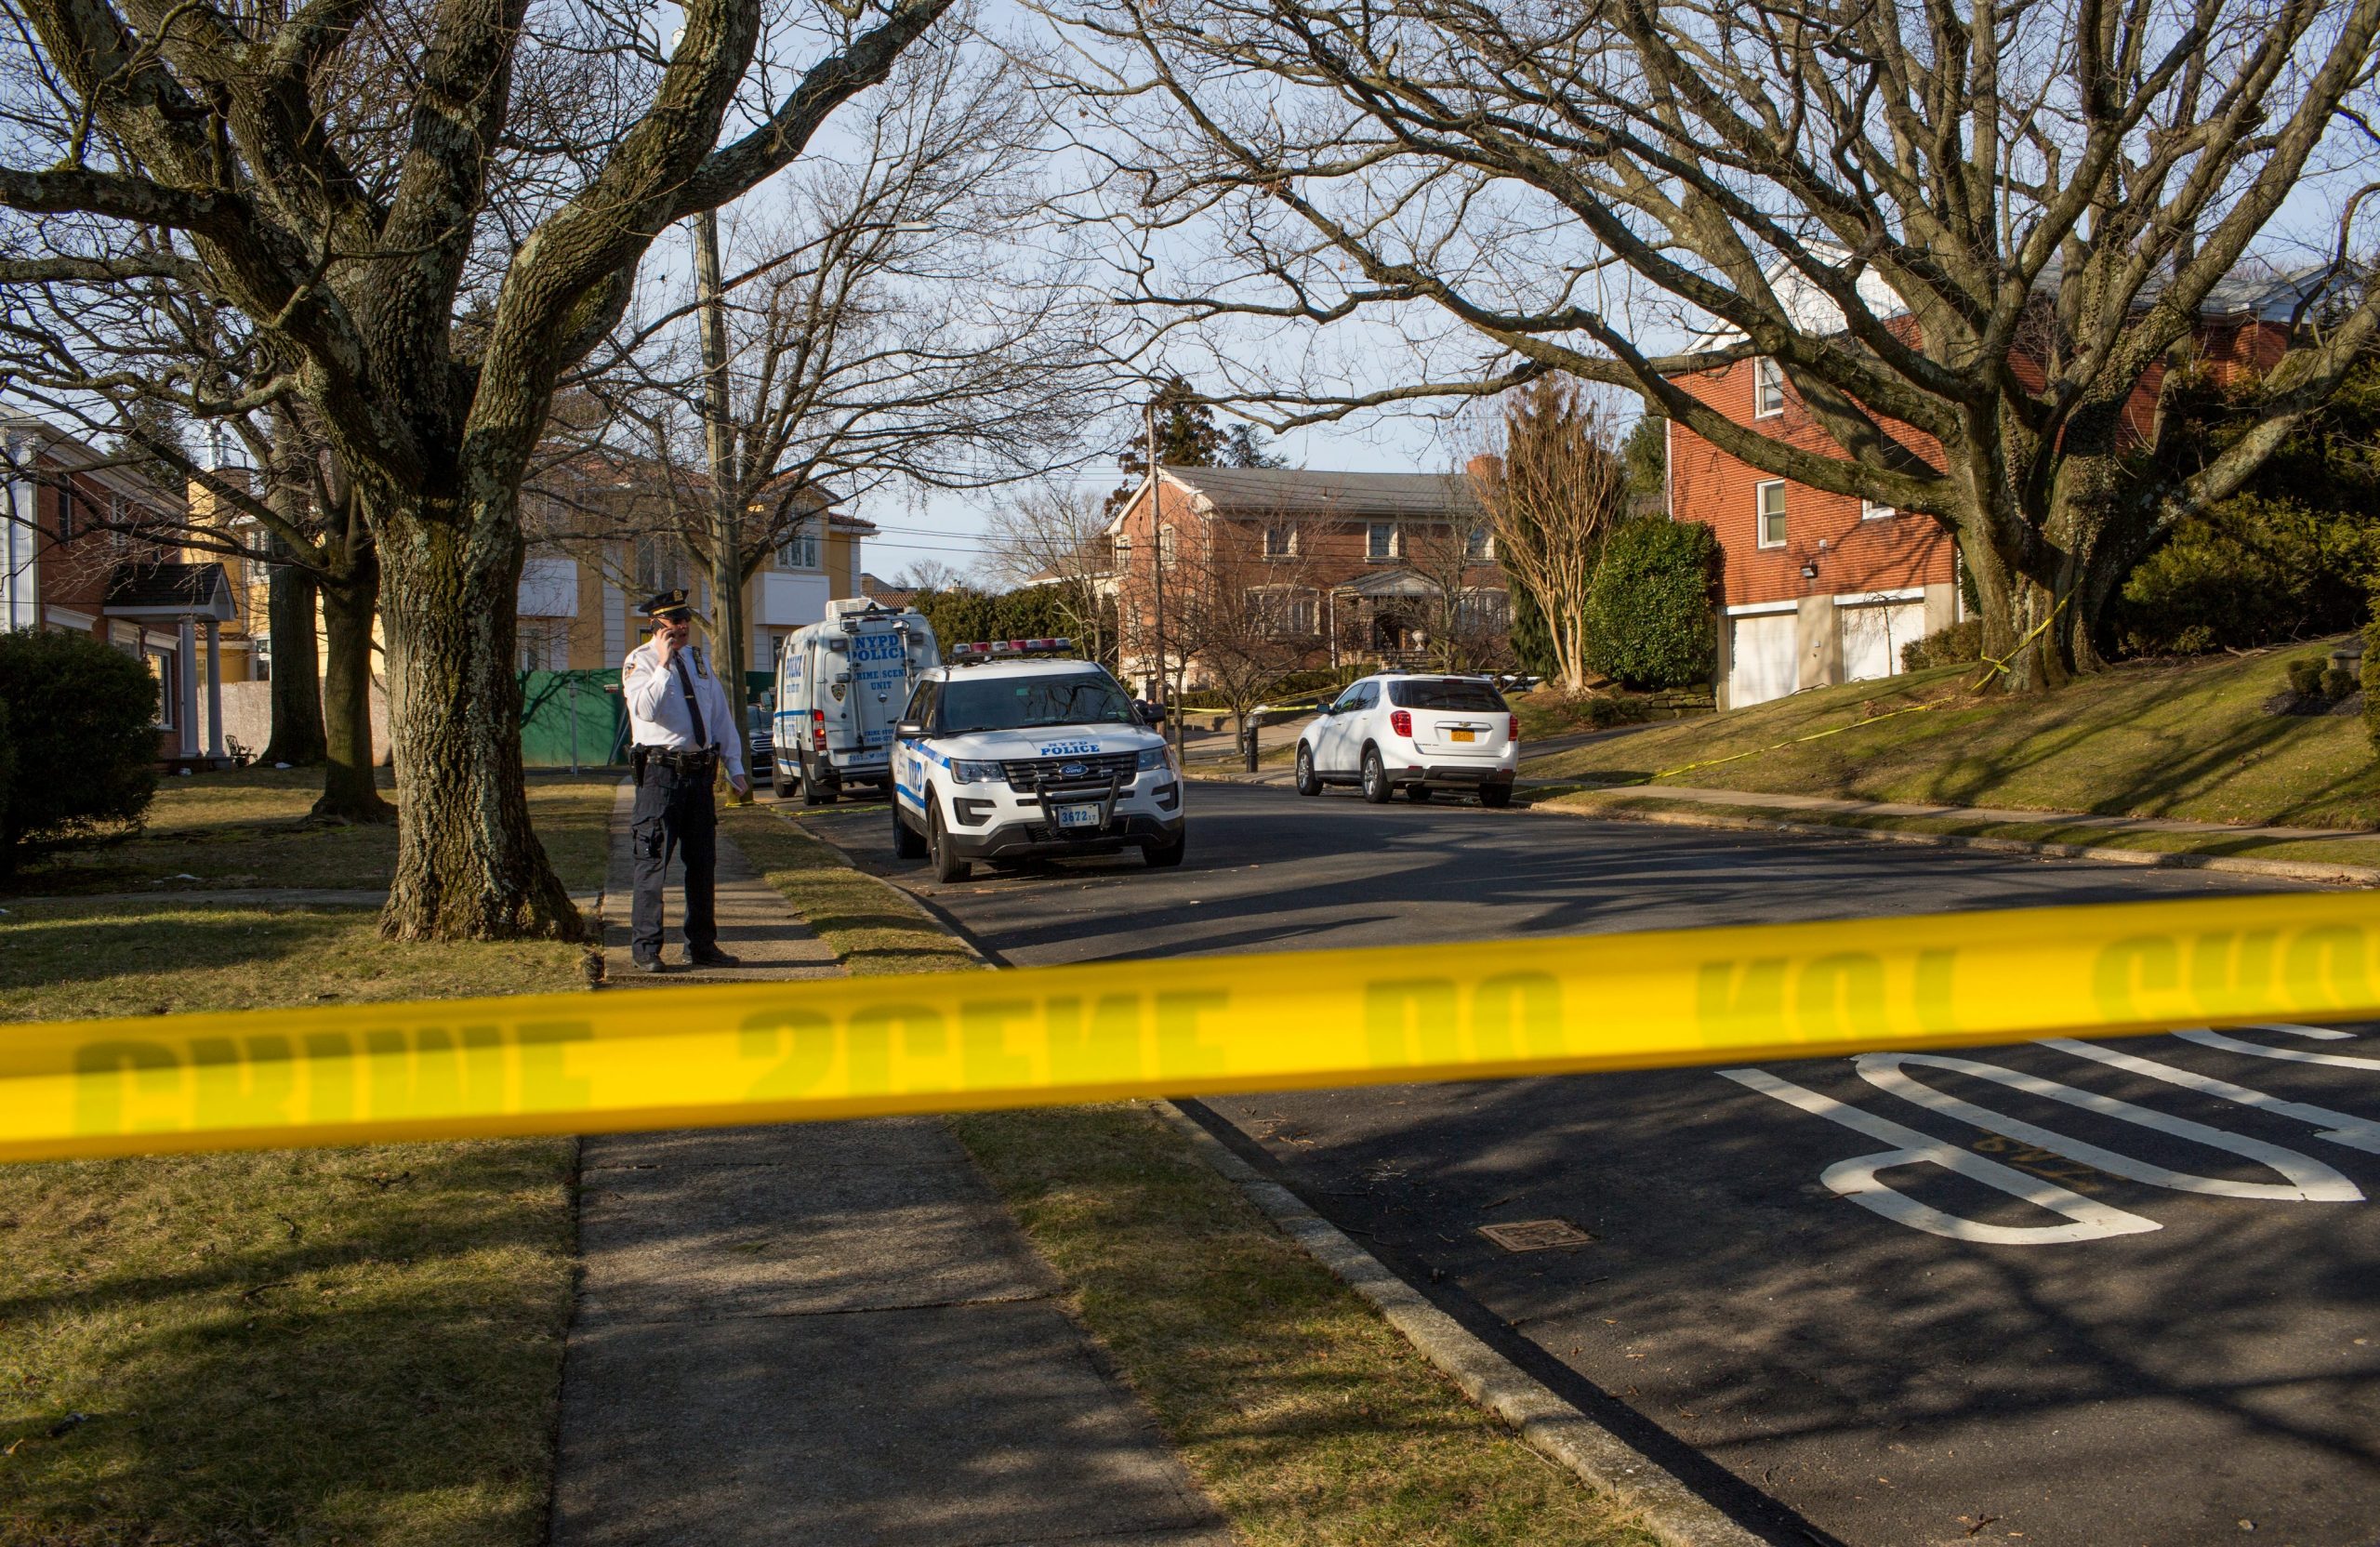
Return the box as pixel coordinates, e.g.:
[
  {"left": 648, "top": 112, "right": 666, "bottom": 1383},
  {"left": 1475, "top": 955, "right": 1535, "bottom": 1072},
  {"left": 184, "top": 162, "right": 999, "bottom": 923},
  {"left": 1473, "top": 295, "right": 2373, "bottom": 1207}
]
[{"left": 1718, "top": 1068, "right": 2163, "bottom": 1247}]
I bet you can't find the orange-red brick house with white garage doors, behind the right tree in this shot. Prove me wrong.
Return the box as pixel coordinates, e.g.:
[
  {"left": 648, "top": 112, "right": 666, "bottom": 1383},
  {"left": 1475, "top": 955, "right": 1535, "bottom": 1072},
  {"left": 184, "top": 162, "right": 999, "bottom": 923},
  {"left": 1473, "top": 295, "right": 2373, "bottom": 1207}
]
[{"left": 1669, "top": 271, "right": 2316, "bottom": 709}]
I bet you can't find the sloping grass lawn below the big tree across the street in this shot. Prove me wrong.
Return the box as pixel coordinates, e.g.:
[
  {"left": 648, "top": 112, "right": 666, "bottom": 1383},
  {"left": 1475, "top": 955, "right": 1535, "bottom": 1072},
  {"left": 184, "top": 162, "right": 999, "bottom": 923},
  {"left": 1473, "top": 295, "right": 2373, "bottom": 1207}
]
[{"left": 1523, "top": 642, "right": 2380, "bottom": 847}]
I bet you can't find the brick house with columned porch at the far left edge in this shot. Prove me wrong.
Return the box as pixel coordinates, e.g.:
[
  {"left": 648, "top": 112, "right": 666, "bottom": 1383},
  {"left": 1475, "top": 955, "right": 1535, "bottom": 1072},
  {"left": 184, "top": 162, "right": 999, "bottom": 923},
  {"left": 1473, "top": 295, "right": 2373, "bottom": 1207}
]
[{"left": 0, "top": 419, "right": 259, "bottom": 766}]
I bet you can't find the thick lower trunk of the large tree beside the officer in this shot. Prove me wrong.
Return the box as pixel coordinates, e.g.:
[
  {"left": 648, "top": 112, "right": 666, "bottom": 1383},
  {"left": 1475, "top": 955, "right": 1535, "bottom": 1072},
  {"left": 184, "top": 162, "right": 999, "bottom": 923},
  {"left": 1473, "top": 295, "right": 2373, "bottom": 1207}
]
[{"left": 374, "top": 490, "right": 586, "bottom": 940}]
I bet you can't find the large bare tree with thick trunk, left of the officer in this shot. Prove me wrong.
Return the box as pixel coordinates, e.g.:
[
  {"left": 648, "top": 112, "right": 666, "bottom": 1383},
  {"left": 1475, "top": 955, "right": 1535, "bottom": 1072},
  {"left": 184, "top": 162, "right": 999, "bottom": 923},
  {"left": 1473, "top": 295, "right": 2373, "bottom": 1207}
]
[{"left": 0, "top": 0, "right": 952, "bottom": 938}]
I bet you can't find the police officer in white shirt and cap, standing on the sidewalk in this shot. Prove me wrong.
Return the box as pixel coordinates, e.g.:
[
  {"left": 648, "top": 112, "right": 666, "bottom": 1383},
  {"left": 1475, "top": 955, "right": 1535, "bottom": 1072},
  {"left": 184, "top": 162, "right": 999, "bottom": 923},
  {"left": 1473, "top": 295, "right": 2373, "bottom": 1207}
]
[{"left": 619, "top": 590, "right": 752, "bottom": 973}]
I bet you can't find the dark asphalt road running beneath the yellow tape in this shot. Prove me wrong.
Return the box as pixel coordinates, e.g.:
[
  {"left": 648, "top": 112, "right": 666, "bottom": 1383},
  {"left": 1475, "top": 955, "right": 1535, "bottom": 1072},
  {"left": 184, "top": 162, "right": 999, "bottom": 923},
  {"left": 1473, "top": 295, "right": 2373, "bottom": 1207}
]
[{"left": 816, "top": 786, "right": 2380, "bottom": 1547}]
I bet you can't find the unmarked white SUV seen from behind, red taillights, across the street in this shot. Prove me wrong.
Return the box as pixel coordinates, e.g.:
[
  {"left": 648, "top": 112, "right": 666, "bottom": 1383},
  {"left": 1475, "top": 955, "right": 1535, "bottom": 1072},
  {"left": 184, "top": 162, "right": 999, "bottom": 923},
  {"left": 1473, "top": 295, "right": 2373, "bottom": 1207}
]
[{"left": 1297, "top": 671, "right": 1521, "bottom": 807}]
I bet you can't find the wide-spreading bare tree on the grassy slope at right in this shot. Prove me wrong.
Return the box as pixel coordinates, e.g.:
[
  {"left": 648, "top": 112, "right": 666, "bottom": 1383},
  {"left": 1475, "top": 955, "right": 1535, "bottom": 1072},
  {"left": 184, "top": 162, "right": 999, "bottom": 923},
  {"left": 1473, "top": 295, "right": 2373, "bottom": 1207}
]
[{"left": 1071, "top": 0, "right": 2380, "bottom": 688}]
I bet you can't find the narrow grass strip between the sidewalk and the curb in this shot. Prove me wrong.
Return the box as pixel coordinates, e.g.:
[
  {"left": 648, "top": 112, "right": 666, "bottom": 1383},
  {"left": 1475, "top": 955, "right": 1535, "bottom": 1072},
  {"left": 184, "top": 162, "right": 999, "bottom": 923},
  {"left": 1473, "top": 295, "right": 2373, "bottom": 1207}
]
[{"left": 726, "top": 807, "right": 1652, "bottom": 1547}]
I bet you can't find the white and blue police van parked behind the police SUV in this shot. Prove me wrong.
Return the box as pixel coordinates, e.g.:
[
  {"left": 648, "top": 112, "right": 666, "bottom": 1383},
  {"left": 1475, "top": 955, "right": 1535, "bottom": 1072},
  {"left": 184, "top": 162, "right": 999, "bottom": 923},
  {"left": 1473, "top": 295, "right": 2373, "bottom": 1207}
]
[{"left": 771, "top": 598, "right": 940, "bottom": 804}]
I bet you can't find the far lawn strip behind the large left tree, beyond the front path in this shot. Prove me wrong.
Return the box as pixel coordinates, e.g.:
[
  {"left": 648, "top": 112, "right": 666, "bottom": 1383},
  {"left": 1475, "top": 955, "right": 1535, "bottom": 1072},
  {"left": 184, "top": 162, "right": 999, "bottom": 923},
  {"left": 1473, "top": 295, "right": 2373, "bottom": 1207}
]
[{"left": 0, "top": 769, "right": 619, "bottom": 897}]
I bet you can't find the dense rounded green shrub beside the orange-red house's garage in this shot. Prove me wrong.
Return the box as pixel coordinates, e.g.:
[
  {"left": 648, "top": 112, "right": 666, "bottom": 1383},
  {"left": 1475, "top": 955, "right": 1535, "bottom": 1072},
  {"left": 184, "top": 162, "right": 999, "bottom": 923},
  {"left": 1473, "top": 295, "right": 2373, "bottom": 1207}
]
[{"left": 1588, "top": 517, "right": 1718, "bottom": 688}]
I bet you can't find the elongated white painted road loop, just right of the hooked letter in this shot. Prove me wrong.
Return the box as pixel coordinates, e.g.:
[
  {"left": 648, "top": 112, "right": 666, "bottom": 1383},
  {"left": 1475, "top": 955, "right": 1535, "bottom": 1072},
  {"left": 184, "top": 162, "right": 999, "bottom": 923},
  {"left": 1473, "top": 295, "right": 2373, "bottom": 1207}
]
[{"left": 1852, "top": 1052, "right": 2363, "bottom": 1204}]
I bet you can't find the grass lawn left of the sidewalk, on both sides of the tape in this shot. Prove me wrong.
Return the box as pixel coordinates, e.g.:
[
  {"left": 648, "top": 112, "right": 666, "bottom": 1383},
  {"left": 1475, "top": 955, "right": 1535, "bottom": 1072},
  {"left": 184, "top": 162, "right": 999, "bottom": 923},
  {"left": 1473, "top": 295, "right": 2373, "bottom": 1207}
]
[{"left": 0, "top": 771, "right": 609, "bottom": 1547}]
